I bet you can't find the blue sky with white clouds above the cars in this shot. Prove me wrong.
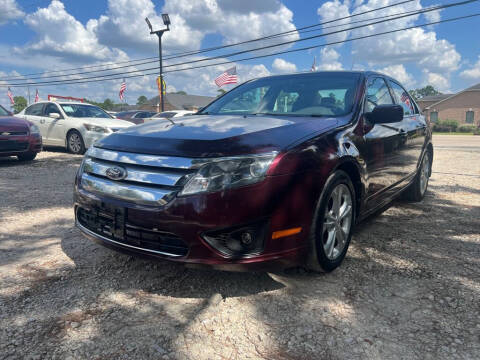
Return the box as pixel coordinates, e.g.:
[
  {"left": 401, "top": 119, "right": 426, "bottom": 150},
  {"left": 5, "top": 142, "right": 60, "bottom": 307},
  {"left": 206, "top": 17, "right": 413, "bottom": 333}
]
[{"left": 0, "top": 0, "right": 480, "bottom": 105}]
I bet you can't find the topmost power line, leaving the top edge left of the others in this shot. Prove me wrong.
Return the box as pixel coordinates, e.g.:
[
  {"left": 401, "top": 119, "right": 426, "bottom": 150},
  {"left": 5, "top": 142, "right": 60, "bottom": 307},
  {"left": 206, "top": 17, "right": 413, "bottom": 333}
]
[{"left": 0, "top": 0, "right": 416, "bottom": 81}]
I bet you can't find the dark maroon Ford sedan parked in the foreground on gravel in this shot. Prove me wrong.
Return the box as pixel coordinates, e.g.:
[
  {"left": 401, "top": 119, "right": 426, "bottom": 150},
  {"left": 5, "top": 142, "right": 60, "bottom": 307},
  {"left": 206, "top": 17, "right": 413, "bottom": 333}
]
[{"left": 75, "top": 71, "right": 433, "bottom": 271}]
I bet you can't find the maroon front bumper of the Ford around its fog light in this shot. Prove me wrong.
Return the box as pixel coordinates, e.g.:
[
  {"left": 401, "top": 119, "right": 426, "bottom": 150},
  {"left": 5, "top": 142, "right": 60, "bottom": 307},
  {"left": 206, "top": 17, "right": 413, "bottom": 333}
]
[{"left": 75, "top": 171, "right": 314, "bottom": 271}]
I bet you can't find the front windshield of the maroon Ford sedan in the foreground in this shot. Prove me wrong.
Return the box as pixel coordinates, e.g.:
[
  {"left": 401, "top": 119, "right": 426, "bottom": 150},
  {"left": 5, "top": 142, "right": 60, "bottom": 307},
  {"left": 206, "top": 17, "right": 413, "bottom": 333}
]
[{"left": 199, "top": 72, "right": 360, "bottom": 116}]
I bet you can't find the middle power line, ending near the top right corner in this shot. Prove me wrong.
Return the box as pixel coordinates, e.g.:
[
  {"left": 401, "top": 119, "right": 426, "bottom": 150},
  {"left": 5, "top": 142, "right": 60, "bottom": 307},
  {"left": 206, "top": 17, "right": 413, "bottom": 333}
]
[{"left": 4, "top": 0, "right": 478, "bottom": 86}]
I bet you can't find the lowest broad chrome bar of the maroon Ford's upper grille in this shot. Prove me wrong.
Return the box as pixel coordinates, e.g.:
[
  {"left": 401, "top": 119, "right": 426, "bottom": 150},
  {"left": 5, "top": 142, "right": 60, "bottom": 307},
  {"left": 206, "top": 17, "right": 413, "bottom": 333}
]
[{"left": 81, "top": 173, "right": 175, "bottom": 206}]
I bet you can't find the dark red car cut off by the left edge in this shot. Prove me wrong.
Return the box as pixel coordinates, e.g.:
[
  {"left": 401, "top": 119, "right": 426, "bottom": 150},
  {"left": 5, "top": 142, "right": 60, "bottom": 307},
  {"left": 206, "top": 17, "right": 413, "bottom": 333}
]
[{"left": 0, "top": 105, "right": 42, "bottom": 161}]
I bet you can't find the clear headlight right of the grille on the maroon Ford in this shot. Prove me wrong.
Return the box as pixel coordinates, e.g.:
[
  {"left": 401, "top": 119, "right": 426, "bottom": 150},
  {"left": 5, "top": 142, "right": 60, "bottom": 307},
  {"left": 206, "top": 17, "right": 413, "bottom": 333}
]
[{"left": 180, "top": 152, "right": 277, "bottom": 195}]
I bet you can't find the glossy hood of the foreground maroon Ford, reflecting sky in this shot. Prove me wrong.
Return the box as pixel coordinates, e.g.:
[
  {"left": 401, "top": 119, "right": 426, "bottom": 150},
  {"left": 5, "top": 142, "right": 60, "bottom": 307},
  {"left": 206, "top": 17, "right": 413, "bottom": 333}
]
[{"left": 95, "top": 115, "right": 337, "bottom": 157}]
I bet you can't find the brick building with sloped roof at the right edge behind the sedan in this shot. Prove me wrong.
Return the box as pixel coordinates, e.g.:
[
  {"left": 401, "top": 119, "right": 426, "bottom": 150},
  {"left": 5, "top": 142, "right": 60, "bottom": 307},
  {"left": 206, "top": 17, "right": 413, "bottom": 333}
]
[{"left": 417, "top": 84, "right": 480, "bottom": 126}]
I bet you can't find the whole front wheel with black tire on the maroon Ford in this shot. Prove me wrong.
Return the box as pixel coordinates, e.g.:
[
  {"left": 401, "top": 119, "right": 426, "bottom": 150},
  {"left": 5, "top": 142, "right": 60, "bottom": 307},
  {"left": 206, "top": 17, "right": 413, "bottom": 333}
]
[{"left": 308, "top": 170, "right": 356, "bottom": 272}]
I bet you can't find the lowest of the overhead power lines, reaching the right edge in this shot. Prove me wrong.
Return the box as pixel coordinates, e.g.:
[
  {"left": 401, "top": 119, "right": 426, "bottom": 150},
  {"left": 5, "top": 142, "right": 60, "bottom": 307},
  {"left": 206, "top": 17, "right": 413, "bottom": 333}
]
[{"left": 1, "top": 13, "right": 480, "bottom": 87}]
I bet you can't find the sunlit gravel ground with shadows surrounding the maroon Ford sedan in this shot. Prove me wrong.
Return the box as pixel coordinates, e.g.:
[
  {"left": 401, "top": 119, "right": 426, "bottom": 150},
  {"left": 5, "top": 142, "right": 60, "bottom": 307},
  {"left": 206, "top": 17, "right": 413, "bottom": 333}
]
[{"left": 0, "top": 136, "right": 480, "bottom": 359}]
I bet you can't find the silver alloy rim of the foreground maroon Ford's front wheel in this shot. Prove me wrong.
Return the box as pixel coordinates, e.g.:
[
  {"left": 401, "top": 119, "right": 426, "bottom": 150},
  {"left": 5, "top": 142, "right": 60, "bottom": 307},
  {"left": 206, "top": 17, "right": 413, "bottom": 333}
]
[{"left": 322, "top": 184, "right": 353, "bottom": 260}]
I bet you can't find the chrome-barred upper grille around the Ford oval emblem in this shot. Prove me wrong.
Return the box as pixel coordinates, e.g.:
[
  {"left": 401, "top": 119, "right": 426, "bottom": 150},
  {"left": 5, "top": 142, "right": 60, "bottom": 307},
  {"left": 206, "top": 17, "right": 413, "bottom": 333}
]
[{"left": 81, "top": 147, "right": 198, "bottom": 206}]
